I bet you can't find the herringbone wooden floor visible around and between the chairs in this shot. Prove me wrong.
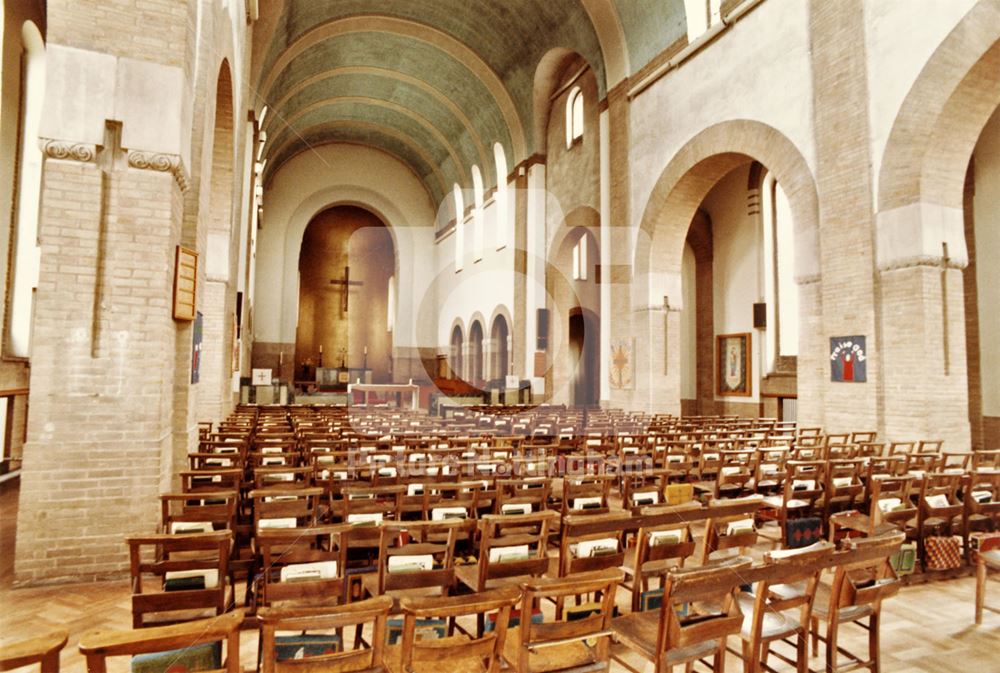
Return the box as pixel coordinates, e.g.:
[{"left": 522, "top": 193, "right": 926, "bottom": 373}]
[{"left": 0, "top": 480, "right": 1000, "bottom": 673}]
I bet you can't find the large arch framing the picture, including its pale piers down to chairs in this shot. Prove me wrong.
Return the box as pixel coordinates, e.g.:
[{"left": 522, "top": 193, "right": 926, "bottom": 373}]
[{"left": 632, "top": 119, "right": 824, "bottom": 419}]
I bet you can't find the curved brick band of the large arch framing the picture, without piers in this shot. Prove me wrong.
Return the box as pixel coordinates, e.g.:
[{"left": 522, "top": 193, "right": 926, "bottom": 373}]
[{"left": 634, "top": 119, "right": 820, "bottom": 292}]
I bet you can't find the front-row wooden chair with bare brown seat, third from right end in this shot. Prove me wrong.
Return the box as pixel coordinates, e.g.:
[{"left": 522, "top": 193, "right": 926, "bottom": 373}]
[{"left": 611, "top": 558, "right": 751, "bottom": 673}]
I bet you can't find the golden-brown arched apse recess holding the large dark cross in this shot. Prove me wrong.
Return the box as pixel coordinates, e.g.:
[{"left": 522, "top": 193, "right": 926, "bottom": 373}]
[{"left": 295, "top": 206, "right": 396, "bottom": 387}]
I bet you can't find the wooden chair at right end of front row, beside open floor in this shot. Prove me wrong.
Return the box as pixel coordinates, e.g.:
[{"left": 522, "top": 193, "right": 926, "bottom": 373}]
[{"left": 811, "top": 533, "right": 906, "bottom": 673}]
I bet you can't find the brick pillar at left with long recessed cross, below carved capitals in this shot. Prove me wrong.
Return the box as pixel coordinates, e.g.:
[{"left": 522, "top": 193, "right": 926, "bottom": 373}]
[{"left": 15, "top": 142, "right": 183, "bottom": 582}]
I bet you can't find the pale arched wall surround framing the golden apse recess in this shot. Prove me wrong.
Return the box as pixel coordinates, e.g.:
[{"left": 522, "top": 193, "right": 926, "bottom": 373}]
[{"left": 254, "top": 144, "right": 435, "bottom": 347}]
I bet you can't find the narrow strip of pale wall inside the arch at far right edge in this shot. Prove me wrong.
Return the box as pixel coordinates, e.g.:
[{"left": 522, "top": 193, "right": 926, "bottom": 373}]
[{"left": 973, "top": 109, "right": 1000, "bottom": 416}]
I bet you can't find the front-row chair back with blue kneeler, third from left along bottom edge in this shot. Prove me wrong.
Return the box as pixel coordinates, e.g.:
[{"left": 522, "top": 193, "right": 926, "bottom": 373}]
[{"left": 257, "top": 596, "right": 392, "bottom": 673}]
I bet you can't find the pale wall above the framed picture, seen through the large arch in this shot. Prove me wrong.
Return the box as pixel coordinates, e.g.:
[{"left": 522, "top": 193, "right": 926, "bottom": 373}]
[{"left": 702, "top": 166, "right": 763, "bottom": 402}]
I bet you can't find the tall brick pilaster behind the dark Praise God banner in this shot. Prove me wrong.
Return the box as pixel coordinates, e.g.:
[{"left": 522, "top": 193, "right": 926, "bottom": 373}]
[{"left": 798, "top": 0, "right": 884, "bottom": 432}]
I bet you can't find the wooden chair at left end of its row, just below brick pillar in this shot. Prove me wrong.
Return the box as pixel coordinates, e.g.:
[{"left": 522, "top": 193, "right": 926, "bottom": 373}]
[{"left": 125, "top": 531, "right": 233, "bottom": 629}]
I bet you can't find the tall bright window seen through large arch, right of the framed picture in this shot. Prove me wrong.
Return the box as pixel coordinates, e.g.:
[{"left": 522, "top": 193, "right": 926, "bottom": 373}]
[{"left": 760, "top": 173, "right": 799, "bottom": 371}]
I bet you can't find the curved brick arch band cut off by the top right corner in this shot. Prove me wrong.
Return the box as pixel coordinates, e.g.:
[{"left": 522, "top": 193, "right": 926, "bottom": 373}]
[{"left": 878, "top": 2, "right": 1000, "bottom": 212}]
